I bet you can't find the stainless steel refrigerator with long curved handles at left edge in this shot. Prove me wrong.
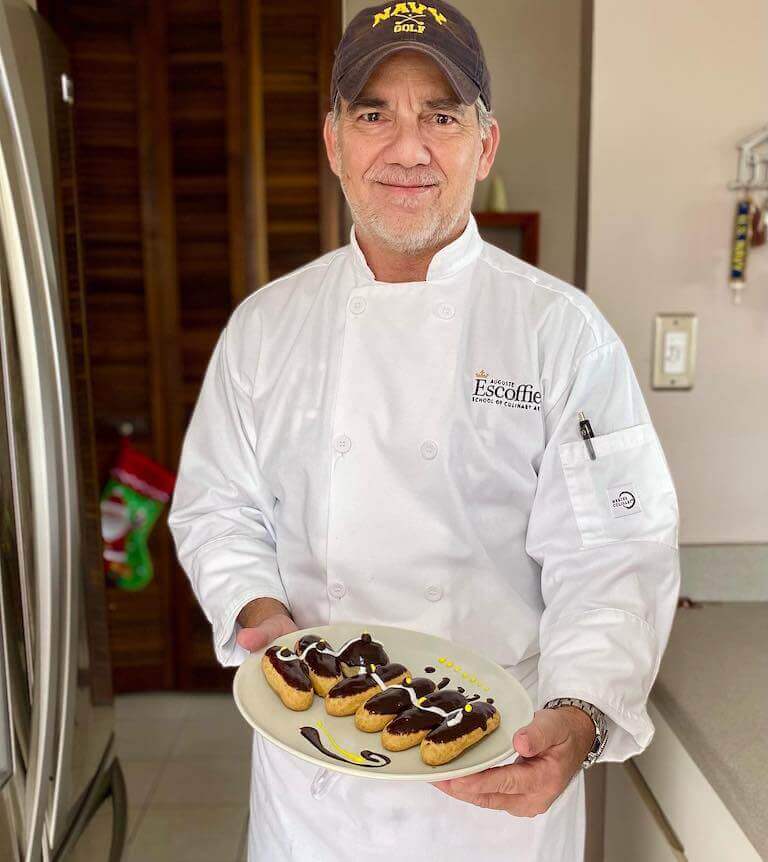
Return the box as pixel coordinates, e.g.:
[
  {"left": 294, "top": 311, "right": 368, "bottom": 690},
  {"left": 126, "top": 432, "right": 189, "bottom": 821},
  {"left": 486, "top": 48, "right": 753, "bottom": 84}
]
[{"left": 0, "top": 0, "right": 126, "bottom": 862}]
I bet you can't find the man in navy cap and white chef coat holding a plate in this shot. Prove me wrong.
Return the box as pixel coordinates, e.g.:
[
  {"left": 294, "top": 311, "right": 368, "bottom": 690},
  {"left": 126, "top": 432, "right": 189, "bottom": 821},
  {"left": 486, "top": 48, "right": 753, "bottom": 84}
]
[{"left": 170, "top": 3, "right": 680, "bottom": 862}]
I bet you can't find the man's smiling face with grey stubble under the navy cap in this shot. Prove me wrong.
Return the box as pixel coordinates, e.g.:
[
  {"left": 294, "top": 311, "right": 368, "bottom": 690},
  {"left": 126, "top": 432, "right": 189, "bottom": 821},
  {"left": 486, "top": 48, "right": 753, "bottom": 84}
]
[{"left": 324, "top": 49, "right": 498, "bottom": 254}]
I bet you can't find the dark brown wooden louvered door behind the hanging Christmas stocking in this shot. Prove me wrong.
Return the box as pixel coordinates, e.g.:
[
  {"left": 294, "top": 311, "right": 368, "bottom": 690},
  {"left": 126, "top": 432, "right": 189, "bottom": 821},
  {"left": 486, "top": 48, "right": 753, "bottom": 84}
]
[{"left": 38, "top": 0, "right": 342, "bottom": 692}]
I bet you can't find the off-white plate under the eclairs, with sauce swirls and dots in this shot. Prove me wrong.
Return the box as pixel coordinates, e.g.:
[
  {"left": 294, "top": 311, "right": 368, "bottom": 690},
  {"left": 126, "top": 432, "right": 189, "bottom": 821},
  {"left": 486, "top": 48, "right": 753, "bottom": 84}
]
[{"left": 232, "top": 623, "right": 533, "bottom": 781}]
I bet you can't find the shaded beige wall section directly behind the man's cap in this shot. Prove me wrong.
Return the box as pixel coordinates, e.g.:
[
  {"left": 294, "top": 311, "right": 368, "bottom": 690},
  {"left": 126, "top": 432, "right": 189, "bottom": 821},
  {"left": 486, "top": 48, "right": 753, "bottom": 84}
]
[{"left": 344, "top": 0, "right": 581, "bottom": 281}]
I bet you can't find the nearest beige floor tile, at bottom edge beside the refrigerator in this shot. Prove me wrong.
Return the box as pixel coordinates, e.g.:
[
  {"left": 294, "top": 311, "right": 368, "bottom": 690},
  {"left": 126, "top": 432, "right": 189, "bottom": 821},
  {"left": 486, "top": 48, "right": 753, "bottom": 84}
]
[{"left": 126, "top": 805, "right": 247, "bottom": 862}]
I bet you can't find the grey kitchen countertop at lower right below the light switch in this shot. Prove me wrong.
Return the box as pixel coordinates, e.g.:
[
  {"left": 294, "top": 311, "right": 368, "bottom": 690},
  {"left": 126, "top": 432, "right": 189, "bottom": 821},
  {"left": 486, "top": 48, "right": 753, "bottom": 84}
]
[{"left": 651, "top": 602, "right": 768, "bottom": 859}]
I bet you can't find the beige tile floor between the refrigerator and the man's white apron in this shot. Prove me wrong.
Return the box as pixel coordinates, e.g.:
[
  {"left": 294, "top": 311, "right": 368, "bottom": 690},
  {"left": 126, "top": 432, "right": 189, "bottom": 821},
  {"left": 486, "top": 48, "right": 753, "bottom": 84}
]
[{"left": 115, "top": 692, "right": 253, "bottom": 862}]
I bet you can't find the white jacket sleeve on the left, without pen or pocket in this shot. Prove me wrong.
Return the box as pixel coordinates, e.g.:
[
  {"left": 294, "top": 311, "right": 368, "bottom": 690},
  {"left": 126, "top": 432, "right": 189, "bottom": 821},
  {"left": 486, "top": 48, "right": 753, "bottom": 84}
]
[{"left": 168, "top": 329, "right": 289, "bottom": 666}]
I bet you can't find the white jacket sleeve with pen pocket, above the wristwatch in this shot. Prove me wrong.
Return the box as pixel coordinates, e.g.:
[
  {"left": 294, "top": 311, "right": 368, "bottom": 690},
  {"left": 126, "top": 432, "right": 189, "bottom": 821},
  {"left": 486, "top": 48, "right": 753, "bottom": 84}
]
[{"left": 526, "top": 340, "right": 680, "bottom": 761}]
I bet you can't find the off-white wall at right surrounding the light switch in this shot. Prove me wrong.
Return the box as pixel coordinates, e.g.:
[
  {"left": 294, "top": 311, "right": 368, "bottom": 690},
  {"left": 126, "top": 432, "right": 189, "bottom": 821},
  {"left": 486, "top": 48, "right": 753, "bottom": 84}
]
[{"left": 587, "top": 0, "right": 768, "bottom": 544}]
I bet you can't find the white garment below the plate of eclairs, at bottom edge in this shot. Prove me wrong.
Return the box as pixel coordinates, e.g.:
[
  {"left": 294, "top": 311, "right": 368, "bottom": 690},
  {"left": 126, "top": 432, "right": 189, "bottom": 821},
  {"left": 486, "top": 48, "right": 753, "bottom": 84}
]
[{"left": 248, "top": 732, "right": 586, "bottom": 862}]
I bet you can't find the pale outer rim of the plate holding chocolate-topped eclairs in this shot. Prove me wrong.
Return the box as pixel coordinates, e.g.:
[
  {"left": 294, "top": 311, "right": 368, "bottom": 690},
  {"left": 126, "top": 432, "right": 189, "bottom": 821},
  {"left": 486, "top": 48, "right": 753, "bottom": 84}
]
[{"left": 232, "top": 620, "right": 534, "bottom": 782}]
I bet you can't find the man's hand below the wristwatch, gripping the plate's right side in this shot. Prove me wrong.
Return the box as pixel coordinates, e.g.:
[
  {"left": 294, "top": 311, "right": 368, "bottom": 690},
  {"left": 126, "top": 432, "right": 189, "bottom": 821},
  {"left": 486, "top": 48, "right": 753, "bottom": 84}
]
[{"left": 431, "top": 706, "right": 595, "bottom": 817}]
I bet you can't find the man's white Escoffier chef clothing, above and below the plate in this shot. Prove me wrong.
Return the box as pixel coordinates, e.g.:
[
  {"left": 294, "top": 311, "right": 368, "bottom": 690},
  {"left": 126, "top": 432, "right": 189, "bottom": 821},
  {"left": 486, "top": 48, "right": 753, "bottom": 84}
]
[{"left": 169, "top": 211, "right": 680, "bottom": 862}]
